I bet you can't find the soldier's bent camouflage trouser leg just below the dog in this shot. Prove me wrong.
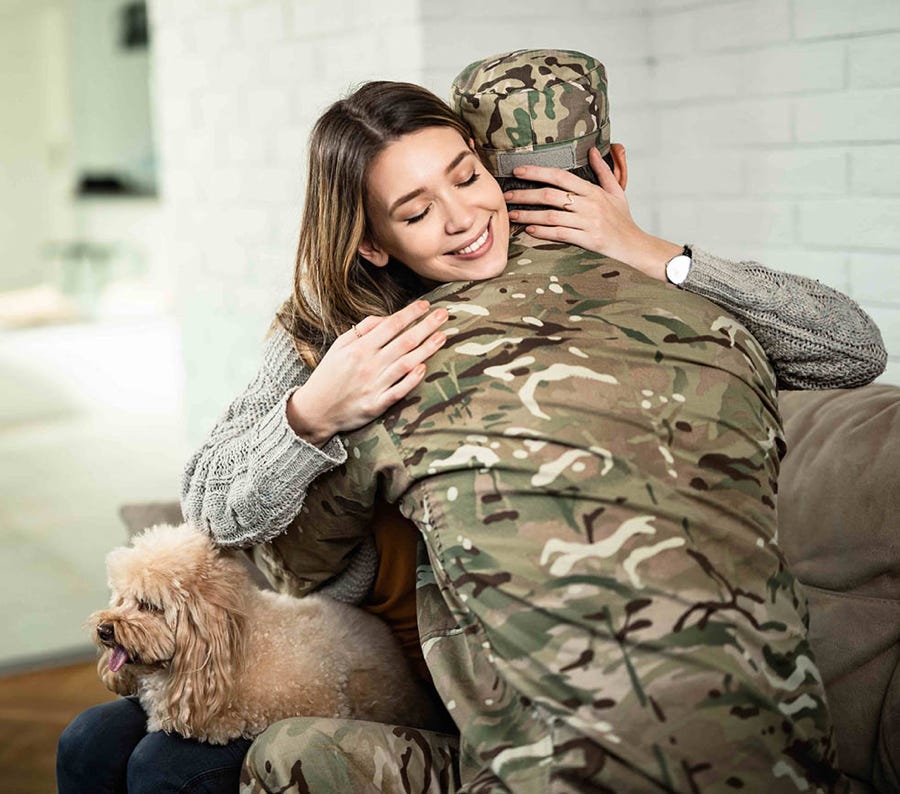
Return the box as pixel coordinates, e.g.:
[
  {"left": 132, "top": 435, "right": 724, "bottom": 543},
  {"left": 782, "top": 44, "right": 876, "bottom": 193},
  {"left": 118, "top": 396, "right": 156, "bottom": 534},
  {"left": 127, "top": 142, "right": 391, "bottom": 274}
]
[{"left": 241, "top": 717, "right": 459, "bottom": 794}]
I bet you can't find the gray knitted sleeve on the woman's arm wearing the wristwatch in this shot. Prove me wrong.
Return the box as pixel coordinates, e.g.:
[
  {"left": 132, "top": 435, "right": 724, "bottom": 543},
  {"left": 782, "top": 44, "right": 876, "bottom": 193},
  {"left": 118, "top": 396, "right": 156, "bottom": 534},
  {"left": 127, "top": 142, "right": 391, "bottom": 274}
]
[{"left": 683, "top": 248, "right": 887, "bottom": 389}]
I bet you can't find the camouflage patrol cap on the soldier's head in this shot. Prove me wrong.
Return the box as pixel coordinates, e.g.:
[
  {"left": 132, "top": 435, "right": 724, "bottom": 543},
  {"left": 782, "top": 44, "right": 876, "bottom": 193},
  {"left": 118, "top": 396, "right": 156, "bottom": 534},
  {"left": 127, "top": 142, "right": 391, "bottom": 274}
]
[{"left": 450, "top": 50, "right": 609, "bottom": 176}]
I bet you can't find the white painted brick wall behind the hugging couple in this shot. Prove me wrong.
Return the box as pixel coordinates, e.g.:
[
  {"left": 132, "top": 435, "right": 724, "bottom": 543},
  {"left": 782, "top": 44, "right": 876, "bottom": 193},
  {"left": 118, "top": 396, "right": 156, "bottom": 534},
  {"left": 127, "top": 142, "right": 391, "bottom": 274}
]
[{"left": 150, "top": 0, "right": 900, "bottom": 439}]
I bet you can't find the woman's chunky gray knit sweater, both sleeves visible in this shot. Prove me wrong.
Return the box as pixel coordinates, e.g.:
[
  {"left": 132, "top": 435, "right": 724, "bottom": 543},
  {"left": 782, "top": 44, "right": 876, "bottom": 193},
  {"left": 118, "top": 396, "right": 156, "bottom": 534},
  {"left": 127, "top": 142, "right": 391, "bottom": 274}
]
[{"left": 182, "top": 248, "right": 887, "bottom": 602}]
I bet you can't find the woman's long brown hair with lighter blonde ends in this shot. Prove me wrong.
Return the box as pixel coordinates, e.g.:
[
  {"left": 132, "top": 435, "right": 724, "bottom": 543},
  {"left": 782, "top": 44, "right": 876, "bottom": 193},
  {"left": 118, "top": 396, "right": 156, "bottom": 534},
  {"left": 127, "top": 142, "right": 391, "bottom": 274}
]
[{"left": 277, "top": 80, "right": 471, "bottom": 366}]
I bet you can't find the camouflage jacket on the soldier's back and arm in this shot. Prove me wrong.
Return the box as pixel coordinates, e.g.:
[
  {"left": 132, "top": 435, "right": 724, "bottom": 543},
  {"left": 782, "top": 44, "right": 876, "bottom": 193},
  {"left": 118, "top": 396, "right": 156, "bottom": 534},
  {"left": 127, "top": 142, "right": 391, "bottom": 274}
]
[{"left": 255, "top": 236, "right": 844, "bottom": 792}]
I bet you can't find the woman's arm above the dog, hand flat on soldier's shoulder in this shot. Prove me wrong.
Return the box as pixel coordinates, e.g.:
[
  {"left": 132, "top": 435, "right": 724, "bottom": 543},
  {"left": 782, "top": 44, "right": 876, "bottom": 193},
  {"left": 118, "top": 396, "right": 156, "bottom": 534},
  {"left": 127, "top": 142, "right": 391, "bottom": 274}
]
[{"left": 182, "top": 301, "right": 447, "bottom": 547}]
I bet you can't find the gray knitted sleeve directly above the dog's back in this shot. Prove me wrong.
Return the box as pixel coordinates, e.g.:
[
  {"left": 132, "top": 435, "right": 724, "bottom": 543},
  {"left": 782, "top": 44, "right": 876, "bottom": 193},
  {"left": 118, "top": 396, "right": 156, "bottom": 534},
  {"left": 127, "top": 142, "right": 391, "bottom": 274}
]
[{"left": 181, "top": 328, "right": 347, "bottom": 547}]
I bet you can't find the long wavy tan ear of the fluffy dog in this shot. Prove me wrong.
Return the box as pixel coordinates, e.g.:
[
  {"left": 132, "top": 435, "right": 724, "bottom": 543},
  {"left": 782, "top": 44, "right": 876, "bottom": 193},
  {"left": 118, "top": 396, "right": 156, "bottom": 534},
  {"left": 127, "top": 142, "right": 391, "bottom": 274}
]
[{"left": 166, "top": 557, "right": 246, "bottom": 738}]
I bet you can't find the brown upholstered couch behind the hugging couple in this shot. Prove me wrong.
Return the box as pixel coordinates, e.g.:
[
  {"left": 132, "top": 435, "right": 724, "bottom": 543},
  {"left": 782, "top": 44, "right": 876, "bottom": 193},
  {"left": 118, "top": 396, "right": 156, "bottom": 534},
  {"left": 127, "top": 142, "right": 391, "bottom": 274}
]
[{"left": 122, "top": 385, "right": 900, "bottom": 794}]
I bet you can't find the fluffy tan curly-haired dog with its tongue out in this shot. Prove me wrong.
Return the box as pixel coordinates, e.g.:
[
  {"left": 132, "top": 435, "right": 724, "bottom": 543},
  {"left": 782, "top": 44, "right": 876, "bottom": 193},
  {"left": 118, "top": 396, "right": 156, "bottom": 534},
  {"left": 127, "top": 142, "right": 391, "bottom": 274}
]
[{"left": 89, "top": 525, "right": 430, "bottom": 744}]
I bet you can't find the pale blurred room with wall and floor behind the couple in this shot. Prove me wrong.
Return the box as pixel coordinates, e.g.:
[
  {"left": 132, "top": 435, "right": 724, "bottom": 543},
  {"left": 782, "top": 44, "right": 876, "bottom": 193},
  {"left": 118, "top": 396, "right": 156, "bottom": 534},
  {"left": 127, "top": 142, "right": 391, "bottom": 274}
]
[{"left": 0, "top": 0, "right": 900, "bottom": 791}]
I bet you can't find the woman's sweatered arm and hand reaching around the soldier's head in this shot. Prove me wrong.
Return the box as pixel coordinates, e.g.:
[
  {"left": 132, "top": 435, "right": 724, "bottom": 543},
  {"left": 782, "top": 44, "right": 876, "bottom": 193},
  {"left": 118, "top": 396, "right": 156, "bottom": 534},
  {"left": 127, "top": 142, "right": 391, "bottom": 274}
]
[{"left": 506, "top": 150, "right": 887, "bottom": 389}]
